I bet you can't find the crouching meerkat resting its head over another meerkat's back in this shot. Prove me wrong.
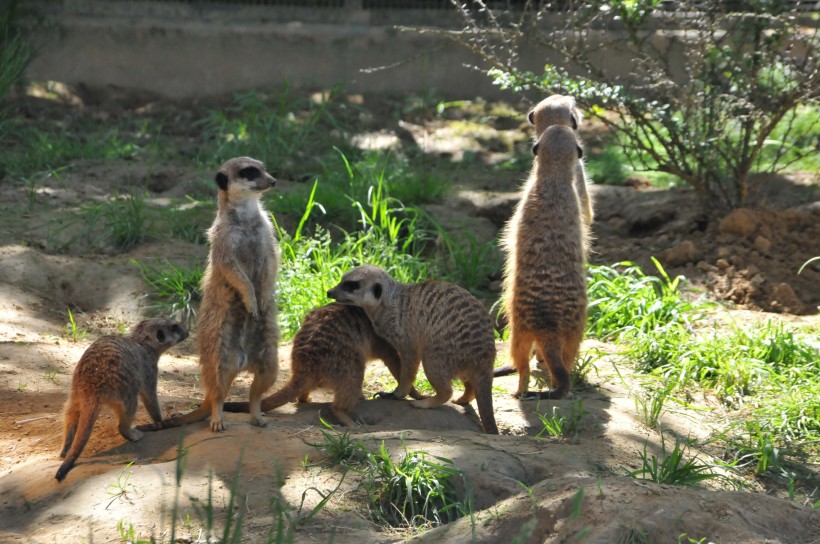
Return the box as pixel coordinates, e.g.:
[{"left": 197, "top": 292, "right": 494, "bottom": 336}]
[{"left": 327, "top": 265, "right": 498, "bottom": 434}]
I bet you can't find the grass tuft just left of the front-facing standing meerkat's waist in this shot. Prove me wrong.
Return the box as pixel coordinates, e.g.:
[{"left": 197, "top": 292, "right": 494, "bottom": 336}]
[{"left": 131, "top": 259, "right": 204, "bottom": 327}]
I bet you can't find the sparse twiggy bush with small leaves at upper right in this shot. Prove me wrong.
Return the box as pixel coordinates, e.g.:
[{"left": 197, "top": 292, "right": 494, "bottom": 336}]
[{"left": 453, "top": 0, "right": 820, "bottom": 209}]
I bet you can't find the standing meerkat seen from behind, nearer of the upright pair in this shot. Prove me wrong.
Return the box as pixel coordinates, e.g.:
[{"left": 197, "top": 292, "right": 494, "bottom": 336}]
[{"left": 495, "top": 125, "right": 587, "bottom": 399}]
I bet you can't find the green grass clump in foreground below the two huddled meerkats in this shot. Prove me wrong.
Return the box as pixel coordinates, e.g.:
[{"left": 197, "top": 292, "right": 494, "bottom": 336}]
[{"left": 363, "top": 443, "right": 466, "bottom": 527}]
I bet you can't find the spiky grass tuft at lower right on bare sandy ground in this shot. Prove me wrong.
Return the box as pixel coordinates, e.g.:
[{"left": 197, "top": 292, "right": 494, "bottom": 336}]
[{"left": 629, "top": 433, "right": 721, "bottom": 487}]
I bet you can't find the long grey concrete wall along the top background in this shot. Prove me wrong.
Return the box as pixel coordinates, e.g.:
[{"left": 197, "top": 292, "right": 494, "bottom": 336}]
[{"left": 26, "top": 1, "right": 528, "bottom": 98}]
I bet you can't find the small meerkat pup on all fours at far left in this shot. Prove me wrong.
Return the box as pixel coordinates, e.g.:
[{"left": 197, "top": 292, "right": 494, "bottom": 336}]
[{"left": 54, "top": 319, "right": 188, "bottom": 482}]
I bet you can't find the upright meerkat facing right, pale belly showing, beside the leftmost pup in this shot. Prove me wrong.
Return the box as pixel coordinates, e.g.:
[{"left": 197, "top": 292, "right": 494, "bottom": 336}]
[{"left": 139, "top": 157, "right": 279, "bottom": 431}]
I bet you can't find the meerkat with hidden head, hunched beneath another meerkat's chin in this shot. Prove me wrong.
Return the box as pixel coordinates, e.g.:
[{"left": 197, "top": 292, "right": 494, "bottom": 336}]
[{"left": 224, "top": 303, "right": 422, "bottom": 427}]
